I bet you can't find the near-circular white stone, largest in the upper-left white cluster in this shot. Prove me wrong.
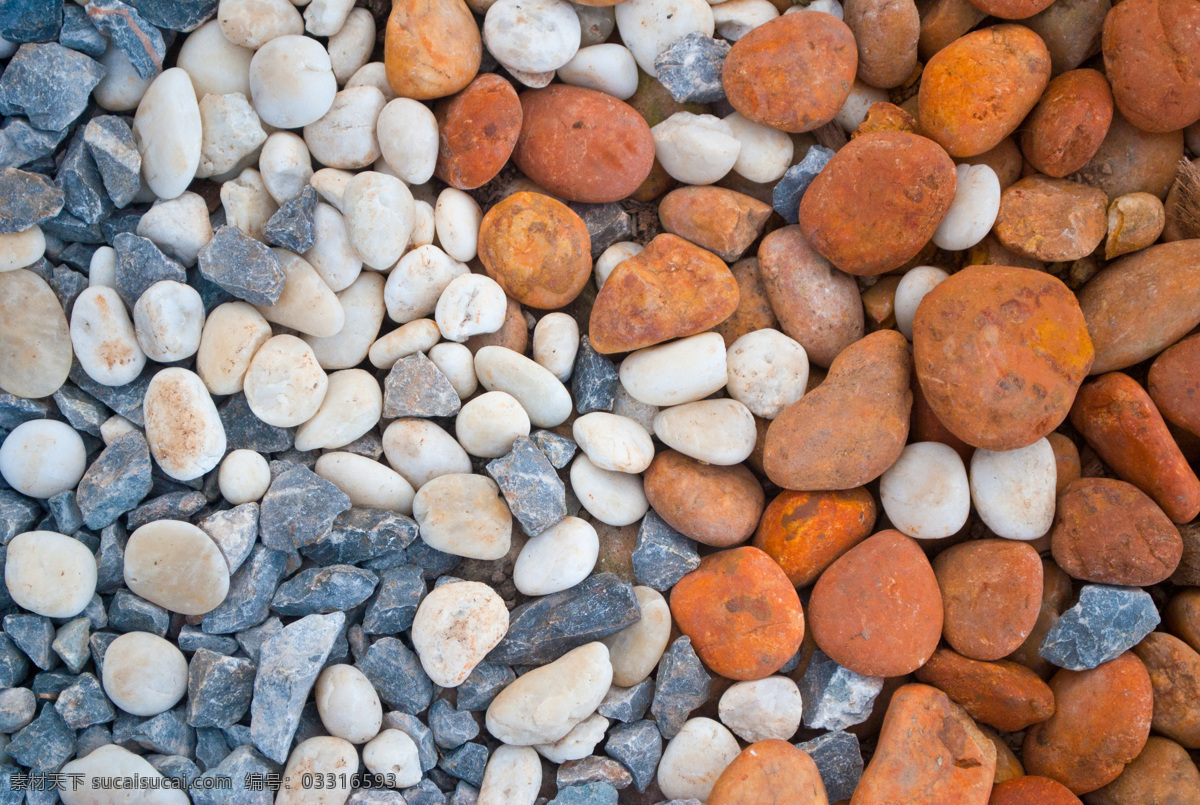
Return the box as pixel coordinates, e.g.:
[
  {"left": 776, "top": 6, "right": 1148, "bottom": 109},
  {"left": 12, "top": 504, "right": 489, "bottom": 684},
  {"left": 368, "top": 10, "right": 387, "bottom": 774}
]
[{"left": 250, "top": 32, "right": 337, "bottom": 128}]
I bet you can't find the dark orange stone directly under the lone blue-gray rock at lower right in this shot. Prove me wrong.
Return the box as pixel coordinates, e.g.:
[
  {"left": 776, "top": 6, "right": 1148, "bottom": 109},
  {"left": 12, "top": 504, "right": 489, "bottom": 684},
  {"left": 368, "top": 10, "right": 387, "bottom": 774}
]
[{"left": 1021, "top": 651, "right": 1154, "bottom": 795}]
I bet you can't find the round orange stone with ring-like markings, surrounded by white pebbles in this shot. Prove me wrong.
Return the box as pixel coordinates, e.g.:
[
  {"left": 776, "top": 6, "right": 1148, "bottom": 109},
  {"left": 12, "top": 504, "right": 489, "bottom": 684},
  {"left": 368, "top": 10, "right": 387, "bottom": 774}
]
[{"left": 479, "top": 193, "right": 592, "bottom": 310}]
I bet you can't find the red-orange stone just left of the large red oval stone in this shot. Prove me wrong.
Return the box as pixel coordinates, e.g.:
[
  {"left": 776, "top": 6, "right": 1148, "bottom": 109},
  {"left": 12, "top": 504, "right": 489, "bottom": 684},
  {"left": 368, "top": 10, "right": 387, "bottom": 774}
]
[{"left": 433, "top": 73, "right": 521, "bottom": 190}]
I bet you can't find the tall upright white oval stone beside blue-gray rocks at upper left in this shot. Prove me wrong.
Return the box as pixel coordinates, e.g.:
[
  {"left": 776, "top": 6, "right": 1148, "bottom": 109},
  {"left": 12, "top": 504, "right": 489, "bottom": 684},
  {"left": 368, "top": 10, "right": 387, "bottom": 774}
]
[{"left": 133, "top": 69, "right": 204, "bottom": 198}]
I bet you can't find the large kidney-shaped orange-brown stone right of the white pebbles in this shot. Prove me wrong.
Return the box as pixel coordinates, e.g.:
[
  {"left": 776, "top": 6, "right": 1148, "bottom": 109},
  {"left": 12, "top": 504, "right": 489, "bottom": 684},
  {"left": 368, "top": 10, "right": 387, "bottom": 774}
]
[{"left": 768, "top": 328, "right": 912, "bottom": 491}]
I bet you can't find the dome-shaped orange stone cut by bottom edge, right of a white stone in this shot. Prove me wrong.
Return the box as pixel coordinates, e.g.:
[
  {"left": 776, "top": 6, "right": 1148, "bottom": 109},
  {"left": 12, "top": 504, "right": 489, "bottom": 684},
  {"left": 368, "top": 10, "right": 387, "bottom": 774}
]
[{"left": 704, "top": 739, "right": 829, "bottom": 805}]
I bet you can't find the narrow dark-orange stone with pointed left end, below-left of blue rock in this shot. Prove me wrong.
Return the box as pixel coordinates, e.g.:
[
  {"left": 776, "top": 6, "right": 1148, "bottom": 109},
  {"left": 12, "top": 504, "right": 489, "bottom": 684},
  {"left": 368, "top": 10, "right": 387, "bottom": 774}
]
[{"left": 917, "top": 648, "right": 1054, "bottom": 732}]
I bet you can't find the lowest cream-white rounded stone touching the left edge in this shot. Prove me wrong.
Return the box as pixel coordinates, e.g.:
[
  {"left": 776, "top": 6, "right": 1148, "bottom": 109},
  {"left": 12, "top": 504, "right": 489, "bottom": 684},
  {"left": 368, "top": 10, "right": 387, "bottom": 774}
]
[{"left": 4, "top": 531, "right": 96, "bottom": 618}]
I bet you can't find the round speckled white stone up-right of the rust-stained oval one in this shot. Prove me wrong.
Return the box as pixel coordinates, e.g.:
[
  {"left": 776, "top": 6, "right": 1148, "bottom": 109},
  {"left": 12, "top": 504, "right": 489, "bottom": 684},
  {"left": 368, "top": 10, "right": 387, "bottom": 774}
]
[{"left": 242, "top": 335, "right": 329, "bottom": 427}]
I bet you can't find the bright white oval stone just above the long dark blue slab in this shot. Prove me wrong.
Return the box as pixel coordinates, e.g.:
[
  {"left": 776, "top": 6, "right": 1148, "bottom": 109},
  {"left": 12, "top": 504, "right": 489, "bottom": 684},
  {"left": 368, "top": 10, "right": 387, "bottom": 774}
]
[{"left": 512, "top": 517, "right": 600, "bottom": 595}]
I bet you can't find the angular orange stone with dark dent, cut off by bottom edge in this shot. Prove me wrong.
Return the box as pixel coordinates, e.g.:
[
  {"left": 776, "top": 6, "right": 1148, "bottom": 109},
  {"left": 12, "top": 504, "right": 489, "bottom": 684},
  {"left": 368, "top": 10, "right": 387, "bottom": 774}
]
[{"left": 850, "top": 685, "right": 996, "bottom": 805}]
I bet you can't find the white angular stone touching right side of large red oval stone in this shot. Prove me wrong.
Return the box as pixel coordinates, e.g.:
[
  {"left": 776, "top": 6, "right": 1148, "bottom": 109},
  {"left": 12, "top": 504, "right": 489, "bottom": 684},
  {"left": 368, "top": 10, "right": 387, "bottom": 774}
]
[{"left": 652, "top": 111, "right": 742, "bottom": 185}]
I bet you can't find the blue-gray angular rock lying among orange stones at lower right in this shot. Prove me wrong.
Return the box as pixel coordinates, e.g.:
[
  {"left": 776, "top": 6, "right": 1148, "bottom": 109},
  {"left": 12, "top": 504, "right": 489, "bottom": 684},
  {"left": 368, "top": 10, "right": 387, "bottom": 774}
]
[{"left": 1038, "top": 584, "right": 1159, "bottom": 671}]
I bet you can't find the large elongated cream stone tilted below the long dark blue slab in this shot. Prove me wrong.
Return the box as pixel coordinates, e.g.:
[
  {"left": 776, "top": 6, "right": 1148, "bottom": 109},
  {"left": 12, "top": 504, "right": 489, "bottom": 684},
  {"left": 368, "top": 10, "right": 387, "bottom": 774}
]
[{"left": 486, "top": 643, "right": 612, "bottom": 746}]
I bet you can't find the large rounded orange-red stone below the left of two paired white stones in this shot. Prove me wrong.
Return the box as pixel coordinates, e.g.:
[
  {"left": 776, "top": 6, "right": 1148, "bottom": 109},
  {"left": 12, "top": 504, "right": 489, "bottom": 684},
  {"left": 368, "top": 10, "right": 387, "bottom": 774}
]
[{"left": 809, "top": 530, "right": 942, "bottom": 677}]
